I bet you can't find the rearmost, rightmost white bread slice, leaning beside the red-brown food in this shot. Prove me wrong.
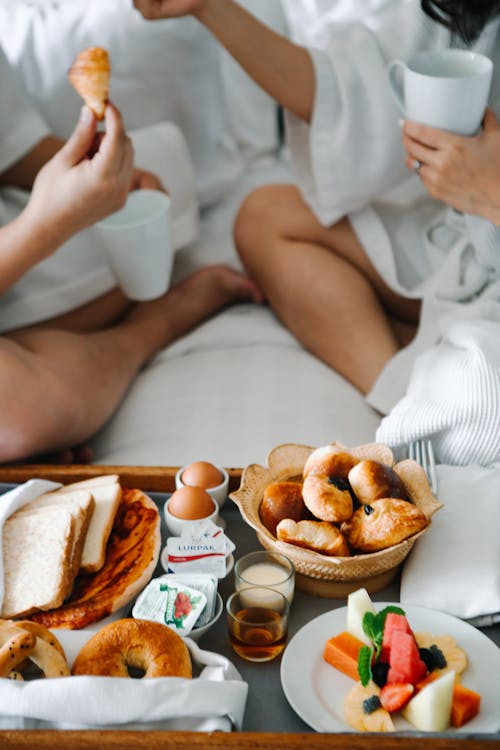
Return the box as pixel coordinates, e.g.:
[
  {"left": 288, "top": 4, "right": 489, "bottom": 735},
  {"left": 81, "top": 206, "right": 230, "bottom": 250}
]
[{"left": 57, "top": 474, "right": 122, "bottom": 573}]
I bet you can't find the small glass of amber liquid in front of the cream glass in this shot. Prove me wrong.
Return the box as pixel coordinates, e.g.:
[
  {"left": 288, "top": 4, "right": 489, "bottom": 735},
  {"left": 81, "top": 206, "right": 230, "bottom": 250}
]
[{"left": 226, "top": 586, "right": 290, "bottom": 662}]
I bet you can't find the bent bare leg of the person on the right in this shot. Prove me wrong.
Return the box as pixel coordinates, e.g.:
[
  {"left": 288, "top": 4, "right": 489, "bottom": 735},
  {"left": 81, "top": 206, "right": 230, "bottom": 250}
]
[{"left": 235, "top": 185, "right": 419, "bottom": 393}]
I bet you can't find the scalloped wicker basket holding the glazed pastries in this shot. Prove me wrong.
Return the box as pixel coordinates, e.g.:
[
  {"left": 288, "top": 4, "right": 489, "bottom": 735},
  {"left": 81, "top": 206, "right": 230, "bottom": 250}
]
[{"left": 230, "top": 443, "right": 442, "bottom": 598}]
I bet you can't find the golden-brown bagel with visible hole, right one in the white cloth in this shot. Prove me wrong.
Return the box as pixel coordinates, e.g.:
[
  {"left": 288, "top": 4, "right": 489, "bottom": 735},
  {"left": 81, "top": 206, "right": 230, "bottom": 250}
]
[{"left": 71, "top": 618, "right": 192, "bottom": 678}]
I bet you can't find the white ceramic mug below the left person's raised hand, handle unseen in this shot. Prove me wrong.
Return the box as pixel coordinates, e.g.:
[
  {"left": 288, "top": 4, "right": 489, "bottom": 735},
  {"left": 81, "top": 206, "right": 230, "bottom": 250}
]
[{"left": 96, "top": 190, "right": 174, "bottom": 301}]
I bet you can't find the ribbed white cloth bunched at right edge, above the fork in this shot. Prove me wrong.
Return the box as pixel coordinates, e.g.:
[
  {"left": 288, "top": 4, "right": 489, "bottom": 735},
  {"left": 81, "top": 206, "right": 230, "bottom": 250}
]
[{"left": 376, "top": 305, "right": 500, "bottom": 466}]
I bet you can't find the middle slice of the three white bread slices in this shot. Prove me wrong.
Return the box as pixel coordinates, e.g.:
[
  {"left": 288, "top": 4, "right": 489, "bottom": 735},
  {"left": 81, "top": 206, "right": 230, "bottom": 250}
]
[{"left": 17, "top": 490, "right": 95, "bottom": 577}]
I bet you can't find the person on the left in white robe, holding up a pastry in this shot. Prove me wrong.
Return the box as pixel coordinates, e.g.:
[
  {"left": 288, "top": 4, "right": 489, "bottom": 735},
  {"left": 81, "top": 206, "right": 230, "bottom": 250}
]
[{"left": 0, "top": 47, "right": 260, "bottom": 462}]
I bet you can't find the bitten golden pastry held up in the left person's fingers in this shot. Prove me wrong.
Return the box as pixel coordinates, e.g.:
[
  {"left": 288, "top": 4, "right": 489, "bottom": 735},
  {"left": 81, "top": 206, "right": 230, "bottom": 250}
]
[{"left": 68, "top": 47, "right": 111, "bottom": 120}]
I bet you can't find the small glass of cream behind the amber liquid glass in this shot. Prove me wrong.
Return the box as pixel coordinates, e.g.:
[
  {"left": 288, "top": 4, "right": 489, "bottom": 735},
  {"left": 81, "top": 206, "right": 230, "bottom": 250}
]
[{"left": 234, "top": 550, "right": 295, "bottom": 604}]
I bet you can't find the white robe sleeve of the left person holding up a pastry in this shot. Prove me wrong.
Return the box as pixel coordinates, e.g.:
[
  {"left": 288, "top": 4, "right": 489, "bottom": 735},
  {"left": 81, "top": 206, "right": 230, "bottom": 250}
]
[{"left": 0, "top": 48, "right": 49, "bottom": 171}]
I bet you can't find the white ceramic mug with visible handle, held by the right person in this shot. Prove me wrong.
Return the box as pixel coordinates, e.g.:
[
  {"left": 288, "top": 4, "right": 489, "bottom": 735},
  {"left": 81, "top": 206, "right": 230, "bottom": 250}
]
[{"left": 388, "top": 49, "right": 493, "bottom": 135}]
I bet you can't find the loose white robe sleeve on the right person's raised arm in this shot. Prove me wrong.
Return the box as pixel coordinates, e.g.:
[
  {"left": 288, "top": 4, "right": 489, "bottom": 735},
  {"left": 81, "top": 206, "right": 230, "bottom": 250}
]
[{"left": 286, "top": 2, "right": 449, "bottom": 225}]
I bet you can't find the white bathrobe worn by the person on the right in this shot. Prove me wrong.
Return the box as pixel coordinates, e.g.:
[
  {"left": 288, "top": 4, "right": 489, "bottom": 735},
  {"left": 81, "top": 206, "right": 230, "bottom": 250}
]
[{"left": 283, "top": 0, "right": 500, "bottom": 412}]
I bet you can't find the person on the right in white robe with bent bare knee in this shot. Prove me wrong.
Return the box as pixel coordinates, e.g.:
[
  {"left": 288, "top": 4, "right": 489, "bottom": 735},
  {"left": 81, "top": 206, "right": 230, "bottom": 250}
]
[{"left": 135, "top": 0, "right": 500, "bottom": 412}]
